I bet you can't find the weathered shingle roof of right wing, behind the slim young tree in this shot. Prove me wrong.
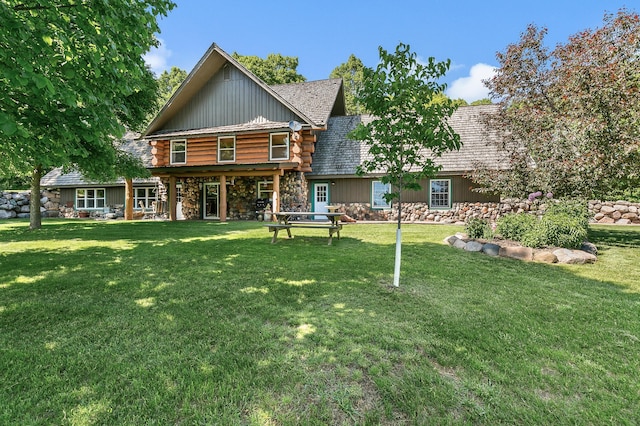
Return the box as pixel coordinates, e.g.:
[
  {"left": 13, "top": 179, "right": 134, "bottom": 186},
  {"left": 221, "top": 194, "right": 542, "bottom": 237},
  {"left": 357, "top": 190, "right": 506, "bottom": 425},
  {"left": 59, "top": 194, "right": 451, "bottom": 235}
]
[{"left": 308, "top": 105, "right": 504, "bottom": 177}]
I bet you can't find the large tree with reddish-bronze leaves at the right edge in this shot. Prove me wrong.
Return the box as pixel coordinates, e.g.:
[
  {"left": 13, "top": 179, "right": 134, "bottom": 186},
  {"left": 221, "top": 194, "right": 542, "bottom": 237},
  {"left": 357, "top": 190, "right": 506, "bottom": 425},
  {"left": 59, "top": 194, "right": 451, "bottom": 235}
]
[{"left": 473, "top": 9, "right": 640, "bottom": 198}]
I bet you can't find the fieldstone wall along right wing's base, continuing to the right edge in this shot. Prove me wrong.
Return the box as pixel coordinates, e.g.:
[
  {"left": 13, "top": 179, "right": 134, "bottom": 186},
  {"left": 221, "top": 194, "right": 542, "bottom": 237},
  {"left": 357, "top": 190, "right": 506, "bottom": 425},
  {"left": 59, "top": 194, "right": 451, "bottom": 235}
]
[{"left": 333, "top": 199, "right": 640, "bottom": 224}]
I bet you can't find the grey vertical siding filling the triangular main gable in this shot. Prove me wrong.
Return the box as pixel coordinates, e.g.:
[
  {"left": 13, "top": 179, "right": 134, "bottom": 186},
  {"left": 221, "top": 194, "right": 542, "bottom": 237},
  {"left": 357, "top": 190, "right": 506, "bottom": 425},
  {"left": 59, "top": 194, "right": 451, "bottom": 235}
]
[{"left": 162, "top": 66, "right": 299, "bottom": 130}]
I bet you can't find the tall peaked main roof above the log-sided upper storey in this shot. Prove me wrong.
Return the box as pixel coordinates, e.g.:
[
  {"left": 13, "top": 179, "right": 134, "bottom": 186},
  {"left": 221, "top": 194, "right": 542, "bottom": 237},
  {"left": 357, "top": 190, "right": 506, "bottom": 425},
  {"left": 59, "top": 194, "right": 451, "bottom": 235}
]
[{"left": 143, "top": 43, "right": 344, "bottom": 138}]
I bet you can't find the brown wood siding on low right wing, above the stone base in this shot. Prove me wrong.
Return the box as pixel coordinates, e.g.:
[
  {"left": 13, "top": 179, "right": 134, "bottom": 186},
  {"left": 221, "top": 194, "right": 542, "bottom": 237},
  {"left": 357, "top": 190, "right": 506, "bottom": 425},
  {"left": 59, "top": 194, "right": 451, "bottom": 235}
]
[{"left": 314, "top": 176, "right": 500, "bottom": 203}]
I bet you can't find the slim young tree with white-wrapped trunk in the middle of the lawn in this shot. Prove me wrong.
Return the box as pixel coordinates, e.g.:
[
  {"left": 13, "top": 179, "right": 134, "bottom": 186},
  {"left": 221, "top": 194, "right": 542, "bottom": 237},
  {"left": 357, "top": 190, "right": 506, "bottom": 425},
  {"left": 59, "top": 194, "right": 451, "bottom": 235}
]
[{"left": 349, "top": 43, "right": 460, "bottom": 287}]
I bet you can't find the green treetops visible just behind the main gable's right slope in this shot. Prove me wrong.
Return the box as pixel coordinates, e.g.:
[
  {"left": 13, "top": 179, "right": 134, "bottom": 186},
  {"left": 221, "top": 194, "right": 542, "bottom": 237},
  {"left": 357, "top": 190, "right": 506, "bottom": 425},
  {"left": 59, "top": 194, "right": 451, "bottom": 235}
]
[{"left": 231, "top": 52, "right": 307, "bottom": 85}]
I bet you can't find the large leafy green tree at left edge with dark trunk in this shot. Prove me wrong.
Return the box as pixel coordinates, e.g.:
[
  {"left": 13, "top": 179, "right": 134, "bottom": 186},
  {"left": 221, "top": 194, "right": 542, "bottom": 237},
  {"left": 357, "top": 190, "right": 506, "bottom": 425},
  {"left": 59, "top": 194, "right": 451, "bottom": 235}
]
[{"left": 0, "top": 0, "right": 174, "bottom": 229}]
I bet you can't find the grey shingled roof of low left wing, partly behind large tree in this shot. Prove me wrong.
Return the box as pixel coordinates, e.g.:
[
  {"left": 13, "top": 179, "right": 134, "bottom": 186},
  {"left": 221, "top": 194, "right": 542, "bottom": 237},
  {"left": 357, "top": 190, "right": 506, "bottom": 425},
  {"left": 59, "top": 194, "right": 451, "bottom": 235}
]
[{"left": 40, "top": 132, "right": 158, "bottom": 188}]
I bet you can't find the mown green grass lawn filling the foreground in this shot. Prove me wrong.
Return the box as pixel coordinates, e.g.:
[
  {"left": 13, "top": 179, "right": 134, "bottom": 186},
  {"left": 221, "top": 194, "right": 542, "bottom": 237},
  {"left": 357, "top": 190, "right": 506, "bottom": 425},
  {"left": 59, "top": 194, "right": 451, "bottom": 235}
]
[{"left": 0, "top": 220, "right": 640, "bottom": 425}]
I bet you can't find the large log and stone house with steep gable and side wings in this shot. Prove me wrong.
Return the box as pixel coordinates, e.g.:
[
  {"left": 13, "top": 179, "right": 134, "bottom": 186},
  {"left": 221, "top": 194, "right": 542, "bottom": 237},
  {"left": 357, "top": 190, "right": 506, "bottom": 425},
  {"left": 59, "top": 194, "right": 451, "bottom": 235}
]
[{"left": 43, "top": 44, "right": 499, "bottom": 221}]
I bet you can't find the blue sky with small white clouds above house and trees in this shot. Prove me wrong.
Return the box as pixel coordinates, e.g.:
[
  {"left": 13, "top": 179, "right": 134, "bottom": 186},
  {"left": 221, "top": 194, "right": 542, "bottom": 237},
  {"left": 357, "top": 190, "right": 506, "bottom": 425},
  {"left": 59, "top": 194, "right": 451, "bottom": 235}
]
[{"left": 146, "top": 0, "right": 640, "bottom": 102}]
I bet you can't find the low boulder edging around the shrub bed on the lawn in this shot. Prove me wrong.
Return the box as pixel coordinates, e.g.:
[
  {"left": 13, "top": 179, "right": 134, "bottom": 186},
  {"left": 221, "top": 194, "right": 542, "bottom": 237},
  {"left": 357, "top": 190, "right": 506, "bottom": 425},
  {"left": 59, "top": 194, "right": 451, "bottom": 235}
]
[{"left": 444, "top": 233, "right": 598, "bottom": 265}]
